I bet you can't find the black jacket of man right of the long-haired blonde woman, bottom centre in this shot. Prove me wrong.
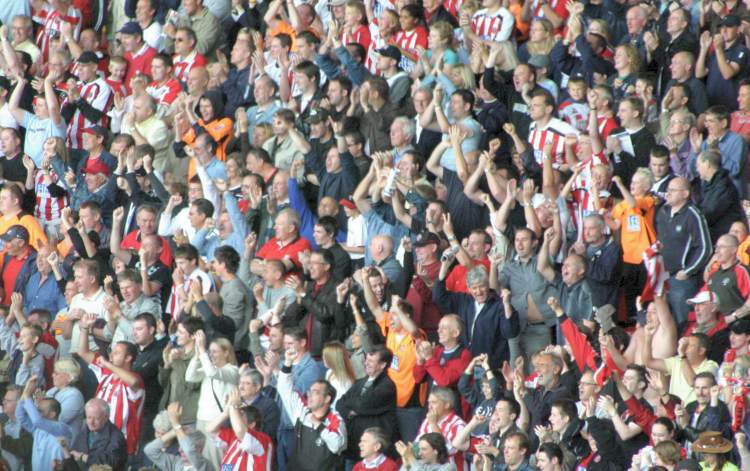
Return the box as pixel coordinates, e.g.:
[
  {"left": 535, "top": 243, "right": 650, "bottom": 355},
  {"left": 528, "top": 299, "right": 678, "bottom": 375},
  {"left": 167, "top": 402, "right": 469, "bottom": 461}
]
[{"left": 336, "top": 368, "right": 398, "bottom": 460}]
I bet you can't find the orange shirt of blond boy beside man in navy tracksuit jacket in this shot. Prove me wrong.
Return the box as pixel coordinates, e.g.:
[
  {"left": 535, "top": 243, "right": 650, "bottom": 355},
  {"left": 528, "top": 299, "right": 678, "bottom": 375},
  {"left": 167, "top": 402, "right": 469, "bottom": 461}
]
[{"left": 612, "top": 195, "right": 656, "bottom": 265}]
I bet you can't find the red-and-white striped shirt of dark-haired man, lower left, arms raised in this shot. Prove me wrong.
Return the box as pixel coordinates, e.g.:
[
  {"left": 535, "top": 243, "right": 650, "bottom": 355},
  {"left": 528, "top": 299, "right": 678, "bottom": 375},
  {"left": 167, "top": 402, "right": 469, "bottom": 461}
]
[{"left": 89, "top": 363, "right": 146, "bottom": 455}]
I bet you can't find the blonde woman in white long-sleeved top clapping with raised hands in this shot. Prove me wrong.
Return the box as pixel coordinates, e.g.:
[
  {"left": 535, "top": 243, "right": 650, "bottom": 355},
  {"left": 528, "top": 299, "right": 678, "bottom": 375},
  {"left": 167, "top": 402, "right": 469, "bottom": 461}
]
[{"left": 185, "top": 330, "right": 240, "bottom": 467}]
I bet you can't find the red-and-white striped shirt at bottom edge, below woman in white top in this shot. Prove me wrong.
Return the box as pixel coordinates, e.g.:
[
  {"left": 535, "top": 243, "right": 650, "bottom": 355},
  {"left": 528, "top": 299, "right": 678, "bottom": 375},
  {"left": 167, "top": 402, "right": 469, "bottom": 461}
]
[{"left": 219, "top": 427, "right": 273, "bottom": 471}]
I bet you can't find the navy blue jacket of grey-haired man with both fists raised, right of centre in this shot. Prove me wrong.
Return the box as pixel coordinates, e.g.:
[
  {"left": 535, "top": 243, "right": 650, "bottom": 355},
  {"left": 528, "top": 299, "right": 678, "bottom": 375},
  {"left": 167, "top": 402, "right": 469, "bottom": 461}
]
[{"left": 432, "top": 279, "right": 521, "bottom": 368}]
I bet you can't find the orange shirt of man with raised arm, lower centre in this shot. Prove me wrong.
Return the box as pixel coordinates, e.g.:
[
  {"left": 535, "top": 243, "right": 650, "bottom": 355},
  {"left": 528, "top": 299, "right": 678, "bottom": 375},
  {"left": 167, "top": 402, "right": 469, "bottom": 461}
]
[{"left": 378, "top": 312, "right": 425, "bottom": 407}]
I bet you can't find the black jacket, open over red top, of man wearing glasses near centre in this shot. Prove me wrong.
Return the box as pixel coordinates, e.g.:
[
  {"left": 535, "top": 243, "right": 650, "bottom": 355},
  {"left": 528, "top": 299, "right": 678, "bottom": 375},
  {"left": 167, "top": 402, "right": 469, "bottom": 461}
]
[{"left": 282, "top": 278, "right": 346, "bottom": 358}]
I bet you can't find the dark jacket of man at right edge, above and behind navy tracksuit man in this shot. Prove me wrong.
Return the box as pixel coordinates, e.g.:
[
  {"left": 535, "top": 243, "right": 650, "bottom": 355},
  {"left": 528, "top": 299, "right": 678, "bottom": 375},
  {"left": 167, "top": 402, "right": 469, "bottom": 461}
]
[{"left": 699, "top": 168, "right": 745, "bottom": 243}]
